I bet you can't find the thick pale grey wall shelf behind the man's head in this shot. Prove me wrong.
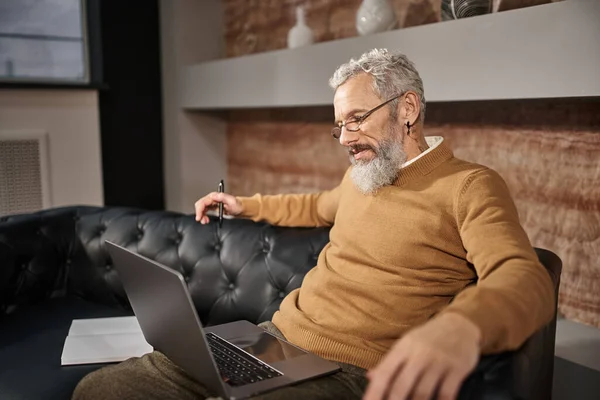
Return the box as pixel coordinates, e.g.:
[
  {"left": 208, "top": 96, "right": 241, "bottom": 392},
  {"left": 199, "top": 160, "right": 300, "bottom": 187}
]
[{"left": 181, "top": 0, "right": 600, "bottom": 110}]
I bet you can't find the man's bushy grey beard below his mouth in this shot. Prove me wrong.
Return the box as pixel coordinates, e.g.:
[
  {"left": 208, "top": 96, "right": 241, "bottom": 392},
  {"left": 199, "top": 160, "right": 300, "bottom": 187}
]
[{"left": 350, "top": 138, "right": 407, "bottom": 195}]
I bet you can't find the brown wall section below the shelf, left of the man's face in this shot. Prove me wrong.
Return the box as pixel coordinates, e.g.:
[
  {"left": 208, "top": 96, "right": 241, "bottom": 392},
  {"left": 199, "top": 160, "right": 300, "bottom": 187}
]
[{"left": 227, "top": 107, "right": 349, "bottom": 195}]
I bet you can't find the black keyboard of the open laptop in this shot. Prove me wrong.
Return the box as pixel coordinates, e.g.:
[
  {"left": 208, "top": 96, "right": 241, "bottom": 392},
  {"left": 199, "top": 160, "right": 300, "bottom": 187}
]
[{"left": 206, "top": 333, "right": 282, "bottom": 386}]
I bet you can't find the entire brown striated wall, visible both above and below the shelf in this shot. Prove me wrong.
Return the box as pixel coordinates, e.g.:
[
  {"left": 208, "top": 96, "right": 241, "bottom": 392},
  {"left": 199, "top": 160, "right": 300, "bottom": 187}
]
[{"left": 225, "top": 0, "right": 600, "bottom": 327}]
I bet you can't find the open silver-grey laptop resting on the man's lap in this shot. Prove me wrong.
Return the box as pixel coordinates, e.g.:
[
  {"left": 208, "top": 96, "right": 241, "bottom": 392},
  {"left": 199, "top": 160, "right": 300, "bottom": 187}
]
[{"left": 106, "top": 241, "right": 339, "bottom": 399}]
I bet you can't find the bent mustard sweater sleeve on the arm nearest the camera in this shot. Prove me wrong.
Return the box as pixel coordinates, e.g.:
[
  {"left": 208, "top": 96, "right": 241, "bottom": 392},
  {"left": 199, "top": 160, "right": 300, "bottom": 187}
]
[{"left": 444, "top": 169, "right": 555, "bottom": 354}]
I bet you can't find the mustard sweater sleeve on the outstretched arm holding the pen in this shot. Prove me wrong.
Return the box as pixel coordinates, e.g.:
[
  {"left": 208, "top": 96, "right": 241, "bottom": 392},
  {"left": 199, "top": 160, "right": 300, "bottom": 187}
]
[{"left": 238, "top": 170, "right": 342, "bottom": 227}]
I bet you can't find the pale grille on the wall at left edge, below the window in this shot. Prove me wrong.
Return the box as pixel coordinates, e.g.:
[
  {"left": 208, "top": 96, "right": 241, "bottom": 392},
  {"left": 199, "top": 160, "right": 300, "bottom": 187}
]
[{"left": 0, "top": 131, "right": 52, "bottom": 216}]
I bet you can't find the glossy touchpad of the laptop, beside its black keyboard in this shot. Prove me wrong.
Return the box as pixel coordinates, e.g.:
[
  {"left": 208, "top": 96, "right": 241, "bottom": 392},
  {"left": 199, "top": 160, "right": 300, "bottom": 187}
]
[{"left": 227, "top": 332, "right": 306, "bottom": 364}]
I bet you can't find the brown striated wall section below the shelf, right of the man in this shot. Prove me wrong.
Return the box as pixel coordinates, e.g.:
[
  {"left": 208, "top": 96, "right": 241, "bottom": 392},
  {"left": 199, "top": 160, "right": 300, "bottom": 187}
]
[{"left": 427, "top": 100, "right": 600, "bottom": 327}]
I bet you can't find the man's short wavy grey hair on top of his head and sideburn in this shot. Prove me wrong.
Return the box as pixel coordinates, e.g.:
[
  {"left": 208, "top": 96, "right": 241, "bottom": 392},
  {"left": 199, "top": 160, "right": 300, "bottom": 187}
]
[{"left": 329, "top": 49, "right": 425, "bottom": 122}]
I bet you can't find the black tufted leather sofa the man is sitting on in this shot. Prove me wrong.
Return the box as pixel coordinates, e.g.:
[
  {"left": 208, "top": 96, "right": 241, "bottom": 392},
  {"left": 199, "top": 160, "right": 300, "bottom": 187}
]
[{"left": 0, "top": 207, "right": 561, "bottom": 400}]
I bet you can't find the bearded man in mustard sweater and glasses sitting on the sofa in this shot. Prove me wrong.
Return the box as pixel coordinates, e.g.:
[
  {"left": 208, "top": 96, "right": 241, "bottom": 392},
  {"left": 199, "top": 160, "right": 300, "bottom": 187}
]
[{"left": 74, "top": 50, "right": 554, "bottom": 400}]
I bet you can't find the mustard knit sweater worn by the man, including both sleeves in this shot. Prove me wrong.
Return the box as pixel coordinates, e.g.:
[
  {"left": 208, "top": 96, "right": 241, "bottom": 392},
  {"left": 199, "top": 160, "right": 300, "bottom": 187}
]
[{"left": 239, "top": 142, "right": 554, "bottom": 369}]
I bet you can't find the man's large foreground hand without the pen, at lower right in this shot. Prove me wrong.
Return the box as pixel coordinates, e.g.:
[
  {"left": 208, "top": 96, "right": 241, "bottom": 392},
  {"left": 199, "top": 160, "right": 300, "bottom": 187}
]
[{"left": 364, "top": 313, "right": 481, "bottom": 400}]
